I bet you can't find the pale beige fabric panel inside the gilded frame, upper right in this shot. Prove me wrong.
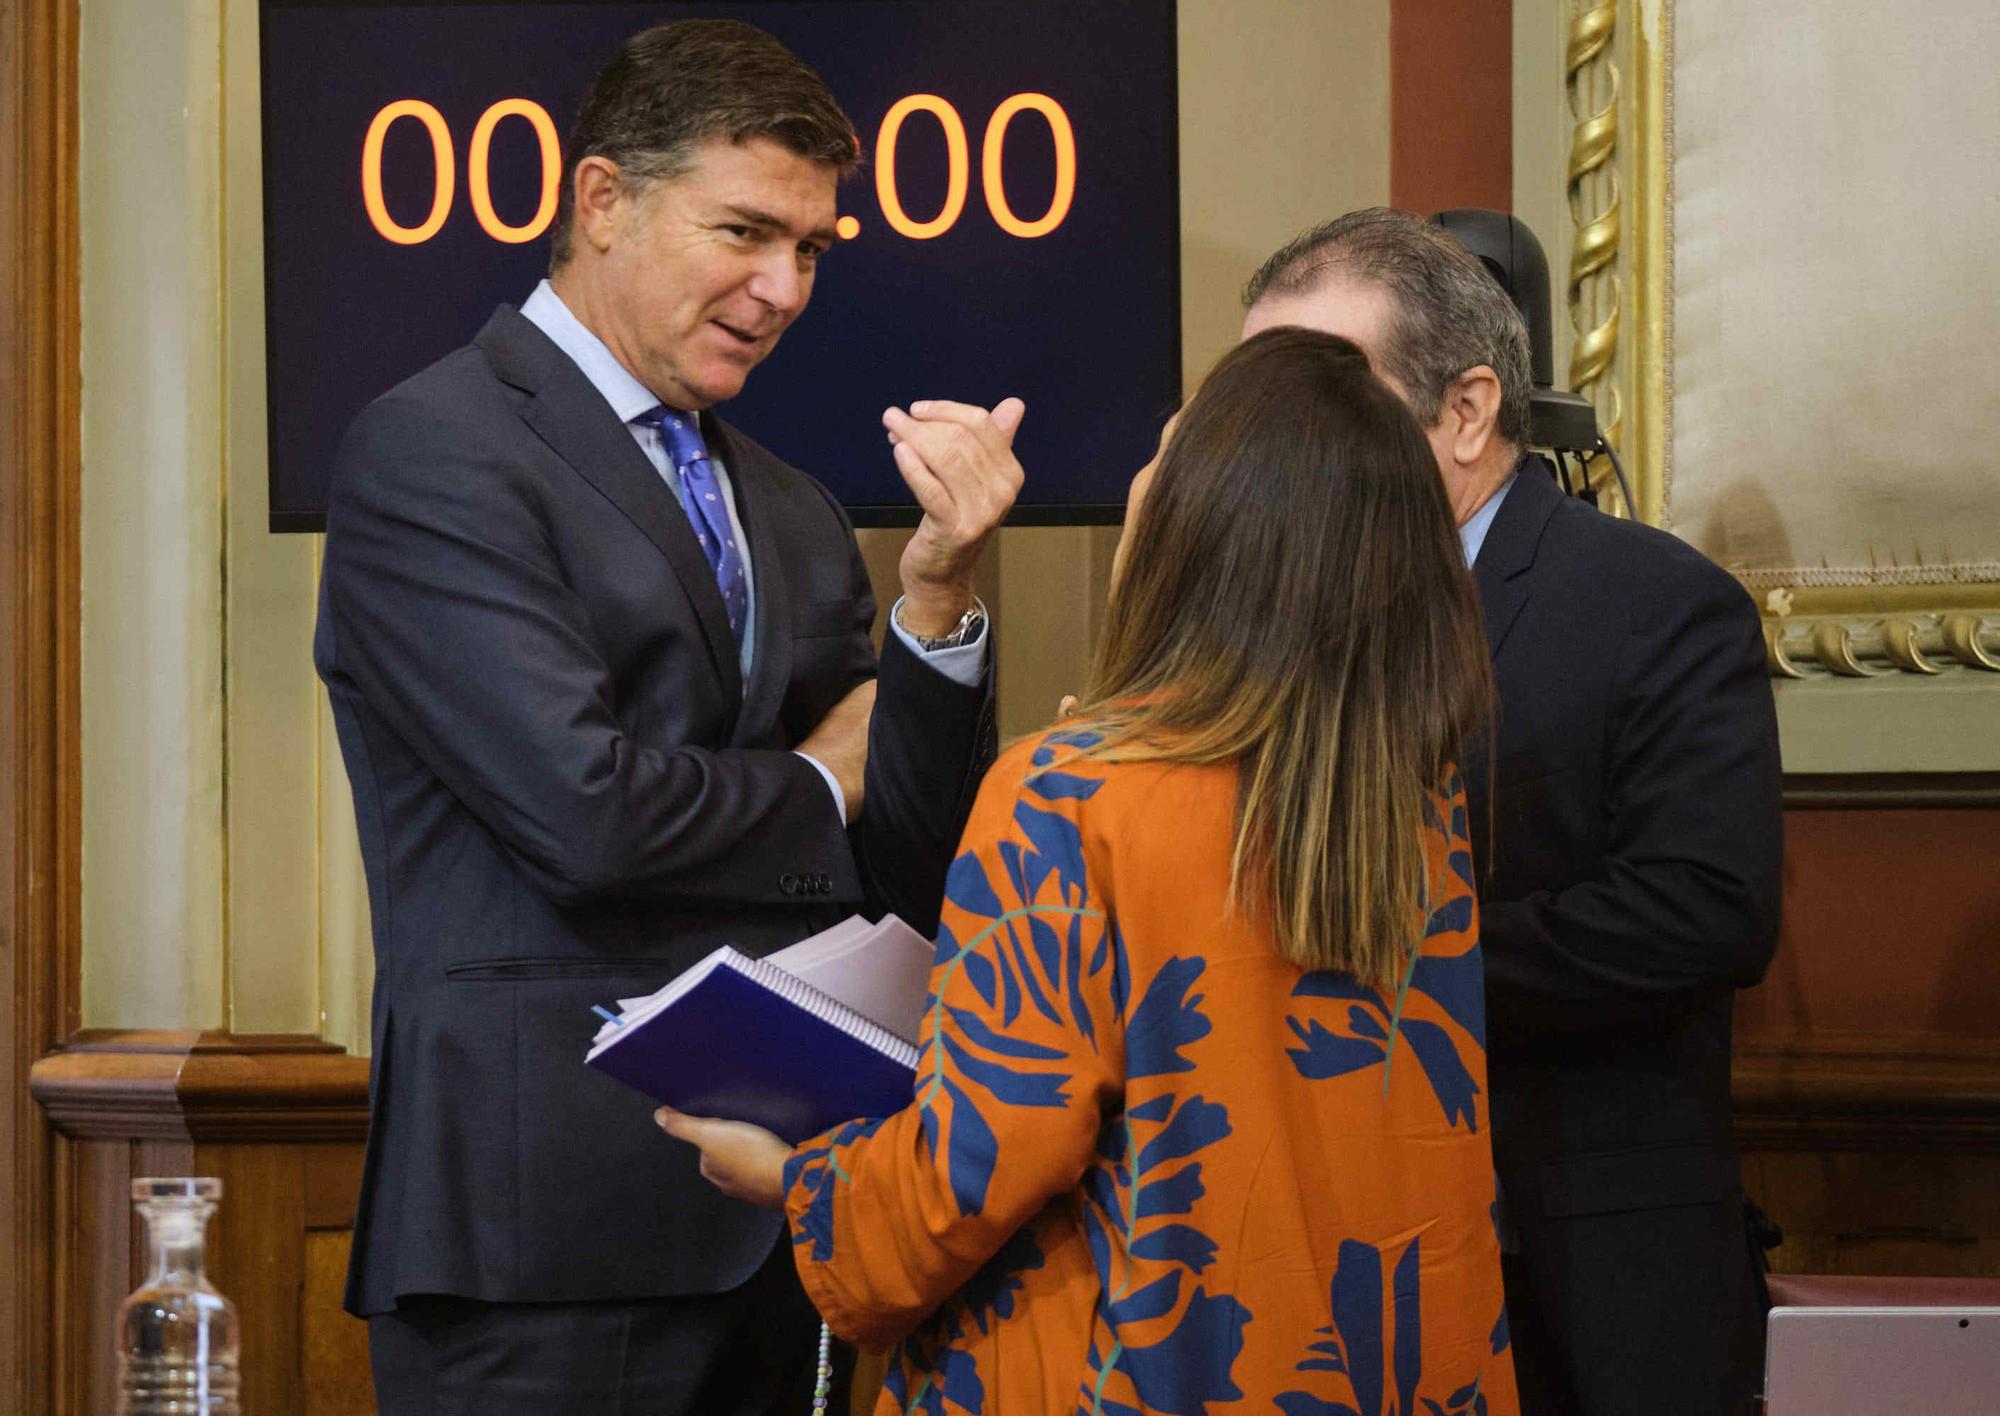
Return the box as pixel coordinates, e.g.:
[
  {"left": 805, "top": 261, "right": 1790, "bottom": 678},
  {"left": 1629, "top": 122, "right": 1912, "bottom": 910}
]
[{"left": 1670, "top": 0, "right": 2000, "bottom": 586}]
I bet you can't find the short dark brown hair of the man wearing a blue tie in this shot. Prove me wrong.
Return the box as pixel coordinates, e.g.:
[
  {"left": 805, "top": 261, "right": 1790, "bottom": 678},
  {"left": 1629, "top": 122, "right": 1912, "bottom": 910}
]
[{"left": 548, "top": 20, "right": 862, "bottom": 270}]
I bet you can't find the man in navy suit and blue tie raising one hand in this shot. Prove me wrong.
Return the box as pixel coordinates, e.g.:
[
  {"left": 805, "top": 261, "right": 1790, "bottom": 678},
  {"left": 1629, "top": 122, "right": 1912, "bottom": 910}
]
[{"left": 314, "top": 22, "right": 1020, "bottom": 1416}]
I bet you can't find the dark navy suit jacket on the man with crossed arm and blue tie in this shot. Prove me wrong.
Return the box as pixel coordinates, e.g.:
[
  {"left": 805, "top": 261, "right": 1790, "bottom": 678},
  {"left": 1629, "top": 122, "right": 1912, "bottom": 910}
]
[{"left": 314, "top": 308, "right": 992, "bottom": 1314}]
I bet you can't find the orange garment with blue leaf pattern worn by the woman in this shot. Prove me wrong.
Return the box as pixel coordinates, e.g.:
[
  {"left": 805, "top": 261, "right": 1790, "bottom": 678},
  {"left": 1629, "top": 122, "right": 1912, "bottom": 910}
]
[{"left": 784, "top": 730, "right": 1518, "bottom": 1416}]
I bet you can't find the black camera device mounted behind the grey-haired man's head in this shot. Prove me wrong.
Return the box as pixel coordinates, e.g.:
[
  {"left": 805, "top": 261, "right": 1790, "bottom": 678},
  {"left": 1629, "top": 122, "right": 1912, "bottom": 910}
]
[{"left": 1430, "top": 206, "right": 1638, "bottom": 516}]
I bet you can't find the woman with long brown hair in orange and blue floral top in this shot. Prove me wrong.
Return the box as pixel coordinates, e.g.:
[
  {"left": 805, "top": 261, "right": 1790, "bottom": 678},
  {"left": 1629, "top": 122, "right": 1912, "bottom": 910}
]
[{"left": 664, "top": 330, "right": 1516, "bottom": 1416}]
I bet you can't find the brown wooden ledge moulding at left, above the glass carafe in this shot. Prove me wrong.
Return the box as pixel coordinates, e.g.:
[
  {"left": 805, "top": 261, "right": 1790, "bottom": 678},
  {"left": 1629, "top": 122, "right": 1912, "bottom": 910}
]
[{"left": 30, "top": 1030, "right": 368, "bottom": 1144}]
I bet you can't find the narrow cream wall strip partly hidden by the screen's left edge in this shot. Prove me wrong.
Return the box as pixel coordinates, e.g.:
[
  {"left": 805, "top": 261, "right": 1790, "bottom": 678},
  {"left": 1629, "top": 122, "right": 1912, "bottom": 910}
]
[{"left": 222, "top": 0, "right": 322, "bottom": 1032}]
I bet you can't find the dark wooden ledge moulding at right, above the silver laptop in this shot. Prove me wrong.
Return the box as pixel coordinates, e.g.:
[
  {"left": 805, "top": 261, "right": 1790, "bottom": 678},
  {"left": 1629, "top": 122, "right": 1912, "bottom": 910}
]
[{"left": 1734, "top": 1034, "right": 2000, "bottom": 1154}]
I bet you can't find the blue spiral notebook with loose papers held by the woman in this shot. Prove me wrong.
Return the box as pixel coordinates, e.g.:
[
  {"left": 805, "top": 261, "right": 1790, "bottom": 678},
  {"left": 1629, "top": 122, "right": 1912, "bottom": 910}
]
[{"left": 584, "top": 916, "right": 932, "bottom": 1144}]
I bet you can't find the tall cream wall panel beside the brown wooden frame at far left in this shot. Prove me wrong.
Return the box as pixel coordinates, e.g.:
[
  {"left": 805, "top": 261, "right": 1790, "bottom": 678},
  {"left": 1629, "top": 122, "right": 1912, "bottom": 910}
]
[{"left": 78, "top": 0, "right": 224, "bottom": 1028}]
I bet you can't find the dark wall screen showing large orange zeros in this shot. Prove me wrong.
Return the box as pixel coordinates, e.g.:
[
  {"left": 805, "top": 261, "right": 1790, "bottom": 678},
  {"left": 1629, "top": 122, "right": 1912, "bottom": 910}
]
[{"left": 262, "top": 0, "right": 1180, "bottom": 530}]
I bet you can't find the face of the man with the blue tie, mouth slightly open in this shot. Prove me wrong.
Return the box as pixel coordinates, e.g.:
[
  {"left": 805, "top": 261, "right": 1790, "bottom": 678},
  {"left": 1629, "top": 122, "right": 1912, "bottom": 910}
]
[{"left": 598, "top": 138, "right": 836, "bottom": 412}]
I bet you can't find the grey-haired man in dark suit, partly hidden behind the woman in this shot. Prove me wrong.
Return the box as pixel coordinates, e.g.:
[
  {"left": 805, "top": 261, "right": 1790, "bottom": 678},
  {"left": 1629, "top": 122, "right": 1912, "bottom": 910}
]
[{"left": 1244, "top": 210, "right": 1784, "bottom": 1416}]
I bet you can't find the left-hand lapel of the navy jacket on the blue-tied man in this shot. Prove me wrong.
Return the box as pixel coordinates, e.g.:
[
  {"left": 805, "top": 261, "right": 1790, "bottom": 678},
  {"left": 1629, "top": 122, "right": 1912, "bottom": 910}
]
[{"left": 474, "top": 306, "right": 744, "bottom": 700}]
